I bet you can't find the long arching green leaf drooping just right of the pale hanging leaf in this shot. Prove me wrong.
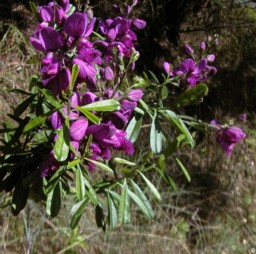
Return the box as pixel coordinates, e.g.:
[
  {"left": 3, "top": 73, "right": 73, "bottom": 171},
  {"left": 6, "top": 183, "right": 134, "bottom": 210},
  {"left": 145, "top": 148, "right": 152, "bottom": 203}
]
[{"left": 158, "top": 110, "right": 195, "bottom": 147}]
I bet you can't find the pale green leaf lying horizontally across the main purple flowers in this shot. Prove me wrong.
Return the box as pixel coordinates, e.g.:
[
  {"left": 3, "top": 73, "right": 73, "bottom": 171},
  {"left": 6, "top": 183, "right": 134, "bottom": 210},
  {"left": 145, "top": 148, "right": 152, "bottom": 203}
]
[{"left": 77, "top": 99, "right": 120, "bottom": 112}]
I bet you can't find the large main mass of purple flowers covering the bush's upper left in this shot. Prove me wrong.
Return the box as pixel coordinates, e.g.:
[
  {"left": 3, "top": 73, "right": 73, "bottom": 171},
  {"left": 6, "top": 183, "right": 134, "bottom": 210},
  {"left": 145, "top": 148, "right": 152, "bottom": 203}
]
[{"left": 30, "top": 0, "right": 146, "bottom": 176}]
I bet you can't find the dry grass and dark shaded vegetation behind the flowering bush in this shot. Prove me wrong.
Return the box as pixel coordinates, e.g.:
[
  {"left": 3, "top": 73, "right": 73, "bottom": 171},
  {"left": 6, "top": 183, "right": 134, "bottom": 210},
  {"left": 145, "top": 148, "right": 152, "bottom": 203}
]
[{"left": 0, "top": 0, "right": 256, "bottom": 253}]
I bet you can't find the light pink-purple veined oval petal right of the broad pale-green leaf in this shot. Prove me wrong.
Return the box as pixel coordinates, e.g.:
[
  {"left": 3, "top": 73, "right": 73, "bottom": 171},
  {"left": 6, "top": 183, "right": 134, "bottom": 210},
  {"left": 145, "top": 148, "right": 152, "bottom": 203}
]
[{"left": 70, "top": 117, "right": 88, "bottom": 141}]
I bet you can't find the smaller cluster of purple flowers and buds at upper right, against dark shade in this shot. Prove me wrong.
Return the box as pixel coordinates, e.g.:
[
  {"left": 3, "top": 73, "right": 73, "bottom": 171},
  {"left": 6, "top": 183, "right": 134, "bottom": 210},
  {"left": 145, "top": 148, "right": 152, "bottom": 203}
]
[{"left": 163, "top": 41, "right": 217, "bottom": 88}]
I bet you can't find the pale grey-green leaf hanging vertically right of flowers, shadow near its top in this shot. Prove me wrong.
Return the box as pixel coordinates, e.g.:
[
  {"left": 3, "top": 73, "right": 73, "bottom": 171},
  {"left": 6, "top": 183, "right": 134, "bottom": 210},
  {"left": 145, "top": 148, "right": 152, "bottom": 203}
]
[{"left": 150, "top": 111, "right": 163, "bottom": 153}]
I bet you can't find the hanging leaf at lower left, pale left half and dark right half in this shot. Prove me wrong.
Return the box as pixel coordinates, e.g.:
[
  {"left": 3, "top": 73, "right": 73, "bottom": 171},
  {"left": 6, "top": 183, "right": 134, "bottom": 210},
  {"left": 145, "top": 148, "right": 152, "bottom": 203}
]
[{"left": 46, "top": 182, "right": 62, "bottom": 217}]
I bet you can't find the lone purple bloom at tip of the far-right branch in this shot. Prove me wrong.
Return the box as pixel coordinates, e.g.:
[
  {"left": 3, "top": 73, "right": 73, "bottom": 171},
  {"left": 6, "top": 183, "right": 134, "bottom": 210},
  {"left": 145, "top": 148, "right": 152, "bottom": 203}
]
[{"left": 211, "top": 120, "right": 246, "bottom": 156}]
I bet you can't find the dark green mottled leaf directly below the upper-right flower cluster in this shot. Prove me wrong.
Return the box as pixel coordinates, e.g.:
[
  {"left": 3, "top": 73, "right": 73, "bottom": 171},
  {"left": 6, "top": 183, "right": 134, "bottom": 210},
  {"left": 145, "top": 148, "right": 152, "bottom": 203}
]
[{"left": 172, "top": 83, "right": 209, "bottom": 108}]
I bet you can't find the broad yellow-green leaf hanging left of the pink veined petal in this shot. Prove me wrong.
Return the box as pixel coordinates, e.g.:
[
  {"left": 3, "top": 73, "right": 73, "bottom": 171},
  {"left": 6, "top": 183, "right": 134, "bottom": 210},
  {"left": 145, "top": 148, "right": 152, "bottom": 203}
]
[{"left": 54, "top": 123, "right": 70, "bottom": 161}]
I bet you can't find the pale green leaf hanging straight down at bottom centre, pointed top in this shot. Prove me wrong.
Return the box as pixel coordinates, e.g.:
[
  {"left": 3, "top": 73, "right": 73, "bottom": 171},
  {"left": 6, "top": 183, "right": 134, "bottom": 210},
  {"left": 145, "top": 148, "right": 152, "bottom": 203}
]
[{"left": 118, "top": 180, "right": 130, "bottom": 223}]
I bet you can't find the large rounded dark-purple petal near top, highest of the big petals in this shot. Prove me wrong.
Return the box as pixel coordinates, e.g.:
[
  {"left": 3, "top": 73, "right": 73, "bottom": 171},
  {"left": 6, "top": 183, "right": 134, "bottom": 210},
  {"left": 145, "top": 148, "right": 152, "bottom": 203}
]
[{"left": 63, "top": 12, "right": 87, "bottom": 37}]
